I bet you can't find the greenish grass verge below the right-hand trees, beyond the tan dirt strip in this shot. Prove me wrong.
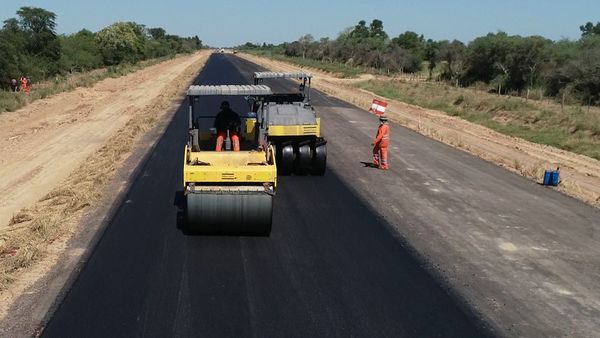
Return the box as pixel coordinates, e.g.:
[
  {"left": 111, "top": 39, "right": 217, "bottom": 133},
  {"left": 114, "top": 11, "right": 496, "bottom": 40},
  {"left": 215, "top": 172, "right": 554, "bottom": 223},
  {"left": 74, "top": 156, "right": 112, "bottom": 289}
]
[{"left": 355, "top": 80, "right": 600, "bottom": 160}]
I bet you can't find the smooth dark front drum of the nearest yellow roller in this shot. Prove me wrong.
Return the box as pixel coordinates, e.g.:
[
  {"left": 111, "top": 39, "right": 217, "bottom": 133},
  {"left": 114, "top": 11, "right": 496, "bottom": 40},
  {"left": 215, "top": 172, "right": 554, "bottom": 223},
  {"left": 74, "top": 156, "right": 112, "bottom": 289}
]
[{"left": 186, "top": 193, "right": 273, "bottom": 236}]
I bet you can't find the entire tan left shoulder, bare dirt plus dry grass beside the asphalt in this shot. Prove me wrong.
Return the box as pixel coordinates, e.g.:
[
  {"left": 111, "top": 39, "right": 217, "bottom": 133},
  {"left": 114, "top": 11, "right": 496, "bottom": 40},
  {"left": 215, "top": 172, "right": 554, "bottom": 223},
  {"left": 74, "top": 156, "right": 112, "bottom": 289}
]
[{"left": 0, "top": 51, "right": 209, "bottom": 324}]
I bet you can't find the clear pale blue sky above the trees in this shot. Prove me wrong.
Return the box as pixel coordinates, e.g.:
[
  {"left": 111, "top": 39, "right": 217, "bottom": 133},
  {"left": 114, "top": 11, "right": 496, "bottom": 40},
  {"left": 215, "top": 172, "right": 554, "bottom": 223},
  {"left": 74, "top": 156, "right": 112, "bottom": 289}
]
[{"left": 0, "top": 0, "right": 600, "bottom": 46}]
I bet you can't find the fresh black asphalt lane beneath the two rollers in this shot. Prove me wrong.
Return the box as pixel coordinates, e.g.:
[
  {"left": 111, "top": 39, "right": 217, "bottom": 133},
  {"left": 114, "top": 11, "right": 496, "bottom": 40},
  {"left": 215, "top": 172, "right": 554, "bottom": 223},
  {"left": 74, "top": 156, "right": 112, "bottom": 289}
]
[{"left": 42, "top": 55, "right": 488, "bottom": 337}]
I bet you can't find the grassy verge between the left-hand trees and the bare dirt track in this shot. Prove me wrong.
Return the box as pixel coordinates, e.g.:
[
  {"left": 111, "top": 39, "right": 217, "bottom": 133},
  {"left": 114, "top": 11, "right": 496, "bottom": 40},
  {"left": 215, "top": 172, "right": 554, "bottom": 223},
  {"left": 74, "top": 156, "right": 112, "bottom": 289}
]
[{"left": 0, "top": 56, "right": 174, "bottom": 113}]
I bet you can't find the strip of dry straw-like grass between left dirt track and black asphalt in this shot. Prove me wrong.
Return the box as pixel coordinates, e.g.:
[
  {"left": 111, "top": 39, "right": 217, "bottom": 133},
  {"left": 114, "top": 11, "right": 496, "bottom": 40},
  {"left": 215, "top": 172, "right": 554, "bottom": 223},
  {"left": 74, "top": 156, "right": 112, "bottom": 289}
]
[{"left": 0, "top": 52, "right": 206, "bottom": 291}]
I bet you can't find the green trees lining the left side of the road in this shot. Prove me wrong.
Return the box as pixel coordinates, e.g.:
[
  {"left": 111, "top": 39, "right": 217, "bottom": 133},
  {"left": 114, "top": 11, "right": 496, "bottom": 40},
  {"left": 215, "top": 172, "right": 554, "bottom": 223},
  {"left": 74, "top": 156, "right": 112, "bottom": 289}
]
[{"left": 0, "top": 7, "right": 202, "bottom": 87}]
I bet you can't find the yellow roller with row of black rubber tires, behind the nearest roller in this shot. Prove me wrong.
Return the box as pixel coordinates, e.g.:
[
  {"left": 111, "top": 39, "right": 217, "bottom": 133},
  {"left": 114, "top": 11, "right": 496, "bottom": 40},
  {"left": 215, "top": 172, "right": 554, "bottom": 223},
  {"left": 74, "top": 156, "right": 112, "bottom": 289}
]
[{"left": 254, "top": 72, "right": 327, "bottom": 176}]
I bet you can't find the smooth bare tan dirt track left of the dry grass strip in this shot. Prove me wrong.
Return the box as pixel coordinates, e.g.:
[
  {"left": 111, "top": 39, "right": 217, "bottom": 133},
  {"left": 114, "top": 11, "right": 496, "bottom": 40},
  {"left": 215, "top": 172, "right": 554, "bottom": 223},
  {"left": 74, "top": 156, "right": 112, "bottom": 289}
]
[{"left": 0, "top": 55, "right": 206, "bottom": 229}]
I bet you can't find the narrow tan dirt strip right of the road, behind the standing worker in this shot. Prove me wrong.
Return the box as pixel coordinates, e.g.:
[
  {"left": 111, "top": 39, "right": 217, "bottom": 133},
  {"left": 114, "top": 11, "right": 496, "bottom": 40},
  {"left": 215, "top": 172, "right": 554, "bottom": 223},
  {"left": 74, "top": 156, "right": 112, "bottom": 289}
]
[{"left": 238, "top": 53, "right": 600, "bottom": 207}]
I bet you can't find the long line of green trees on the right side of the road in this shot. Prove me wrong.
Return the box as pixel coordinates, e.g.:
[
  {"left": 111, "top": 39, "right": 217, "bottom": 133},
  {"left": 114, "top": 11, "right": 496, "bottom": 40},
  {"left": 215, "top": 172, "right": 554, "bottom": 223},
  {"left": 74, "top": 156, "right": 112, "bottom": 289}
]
[{"left": 239, "top": 19, "right": 600, "bottom": 104}]
